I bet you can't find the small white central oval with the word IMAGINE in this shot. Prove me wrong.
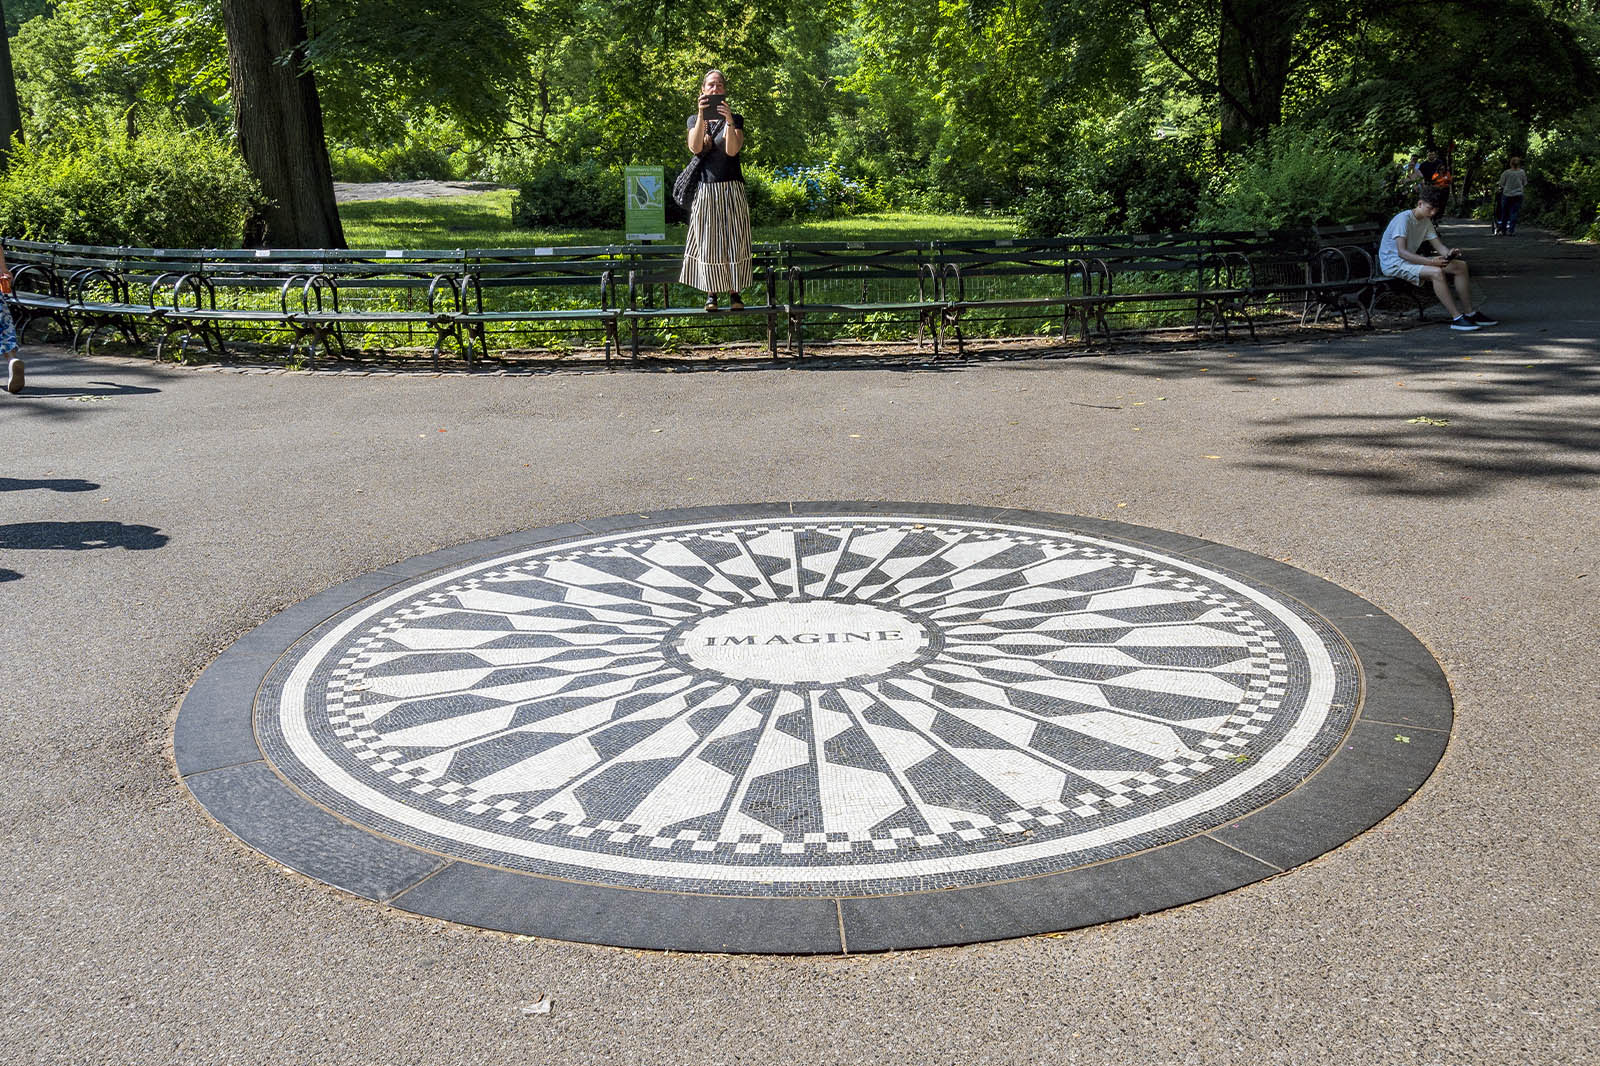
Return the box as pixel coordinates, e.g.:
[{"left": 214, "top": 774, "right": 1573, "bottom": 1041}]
[{"left": 677, "top": 600, "right": 928, "bottom": 685}]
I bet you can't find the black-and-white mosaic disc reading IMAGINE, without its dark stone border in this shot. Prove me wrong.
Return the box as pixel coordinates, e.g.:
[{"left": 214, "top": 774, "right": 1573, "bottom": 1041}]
[{"left": 254, "top": 515, "right": 1358, "bottom": 896}]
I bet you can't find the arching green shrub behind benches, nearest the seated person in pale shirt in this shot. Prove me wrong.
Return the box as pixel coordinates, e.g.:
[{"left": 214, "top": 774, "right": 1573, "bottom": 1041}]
[{"left": 1195, "top": 126, "right": 1389, "bottom": 230}]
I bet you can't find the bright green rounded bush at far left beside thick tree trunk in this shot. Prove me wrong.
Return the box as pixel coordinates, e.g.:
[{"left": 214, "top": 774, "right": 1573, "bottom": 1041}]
[{"left": 0, "top": 120, "right": 259, "bottom": 248}]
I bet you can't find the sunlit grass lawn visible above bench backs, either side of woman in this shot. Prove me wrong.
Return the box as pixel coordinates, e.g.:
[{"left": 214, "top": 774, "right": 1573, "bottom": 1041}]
[{"left": 339, "top": 189, "right": 1016, "bottom": 250}]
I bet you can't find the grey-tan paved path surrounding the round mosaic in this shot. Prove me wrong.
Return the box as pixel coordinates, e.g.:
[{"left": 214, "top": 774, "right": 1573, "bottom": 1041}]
[{"left": 0, "top": 226, "right": 1600, "bottom": 1064}]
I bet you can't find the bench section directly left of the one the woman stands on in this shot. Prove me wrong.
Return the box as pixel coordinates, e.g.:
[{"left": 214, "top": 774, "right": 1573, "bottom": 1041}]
[{"left": 448, "top": 245, "right": 621, "bottom": 368}]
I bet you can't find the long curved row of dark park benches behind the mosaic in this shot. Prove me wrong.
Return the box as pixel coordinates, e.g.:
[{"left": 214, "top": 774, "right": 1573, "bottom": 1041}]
[{"left": 6, "top": 226, "right": 1392, "bottom": 368}]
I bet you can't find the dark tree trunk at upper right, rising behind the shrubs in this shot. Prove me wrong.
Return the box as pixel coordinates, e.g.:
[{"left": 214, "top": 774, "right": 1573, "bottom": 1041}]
[{"left": 1216, "top": 0, "right": 1304, "bottom": 152}]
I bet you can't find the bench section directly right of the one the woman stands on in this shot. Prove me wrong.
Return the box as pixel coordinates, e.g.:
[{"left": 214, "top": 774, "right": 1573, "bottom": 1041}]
[{"left": 782, "top": 240, "right": 947, "bottom": 359}]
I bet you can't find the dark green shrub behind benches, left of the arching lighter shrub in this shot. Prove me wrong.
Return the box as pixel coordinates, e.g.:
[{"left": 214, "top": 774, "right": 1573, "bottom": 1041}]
[{"left": 1016, "top": 107, "right": 1200, "bottom": 237}]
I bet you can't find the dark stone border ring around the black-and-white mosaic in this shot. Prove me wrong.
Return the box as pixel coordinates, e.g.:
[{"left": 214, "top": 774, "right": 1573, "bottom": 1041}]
[{"left": 173, "top": 501, "right": 1454, "bottom": 954}]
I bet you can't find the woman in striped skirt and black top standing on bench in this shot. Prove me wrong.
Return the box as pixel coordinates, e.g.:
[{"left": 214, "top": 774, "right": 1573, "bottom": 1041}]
[{"left": 678, "top": 70, "right": 752, "bottom": 311}]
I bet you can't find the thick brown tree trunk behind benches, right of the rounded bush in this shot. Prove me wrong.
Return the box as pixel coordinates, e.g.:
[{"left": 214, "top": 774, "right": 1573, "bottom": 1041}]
[{"left": 222, "top": 0, "right": 344, "bottom": 248}]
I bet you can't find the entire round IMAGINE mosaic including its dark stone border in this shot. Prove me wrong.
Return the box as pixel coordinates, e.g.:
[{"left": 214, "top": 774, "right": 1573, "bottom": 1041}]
[{"left": 174, "top": 503, "right": 1451, "bottom": 952}]
